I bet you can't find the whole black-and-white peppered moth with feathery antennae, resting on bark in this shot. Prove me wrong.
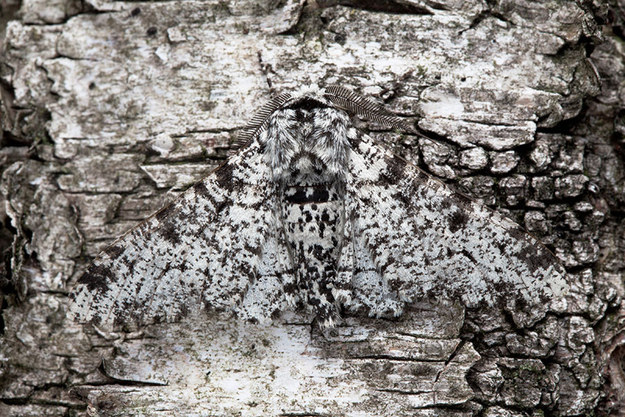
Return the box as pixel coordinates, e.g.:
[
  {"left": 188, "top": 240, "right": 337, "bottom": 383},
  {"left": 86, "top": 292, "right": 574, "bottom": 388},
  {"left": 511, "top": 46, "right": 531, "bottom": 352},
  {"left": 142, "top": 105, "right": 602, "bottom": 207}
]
[{"left": 70, "top": 86, "right": 566, "bottom": 326}]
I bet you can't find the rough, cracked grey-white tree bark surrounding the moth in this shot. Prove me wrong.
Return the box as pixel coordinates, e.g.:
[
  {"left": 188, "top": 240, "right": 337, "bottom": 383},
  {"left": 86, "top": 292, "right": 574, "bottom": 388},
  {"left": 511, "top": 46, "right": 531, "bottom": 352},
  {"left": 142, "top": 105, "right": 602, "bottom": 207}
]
[{"left": 0, "top": 0, "right": 625, "bottom": 416}]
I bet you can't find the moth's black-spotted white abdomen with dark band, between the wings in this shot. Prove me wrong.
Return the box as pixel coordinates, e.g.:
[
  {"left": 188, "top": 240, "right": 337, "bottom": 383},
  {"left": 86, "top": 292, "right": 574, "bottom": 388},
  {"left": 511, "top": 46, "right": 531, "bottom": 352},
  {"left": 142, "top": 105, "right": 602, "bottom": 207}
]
[{"left": 281, "top": 154, "right": 345, "bottom": 310}]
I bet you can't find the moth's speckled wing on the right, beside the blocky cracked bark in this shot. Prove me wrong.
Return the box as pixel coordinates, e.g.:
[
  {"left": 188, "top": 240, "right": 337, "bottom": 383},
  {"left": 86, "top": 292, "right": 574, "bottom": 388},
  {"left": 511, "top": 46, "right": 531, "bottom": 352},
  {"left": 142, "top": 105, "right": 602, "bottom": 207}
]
[{"left": 346, "top": 130, "right": 566, "bottom": 314}]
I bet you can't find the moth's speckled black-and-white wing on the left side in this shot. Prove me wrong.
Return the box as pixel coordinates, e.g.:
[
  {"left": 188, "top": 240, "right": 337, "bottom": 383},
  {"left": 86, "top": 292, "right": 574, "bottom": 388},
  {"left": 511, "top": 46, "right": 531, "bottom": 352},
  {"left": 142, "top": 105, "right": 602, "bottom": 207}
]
[{"left": 70, "top": 142, "right": 290, "bottom": 327}]
